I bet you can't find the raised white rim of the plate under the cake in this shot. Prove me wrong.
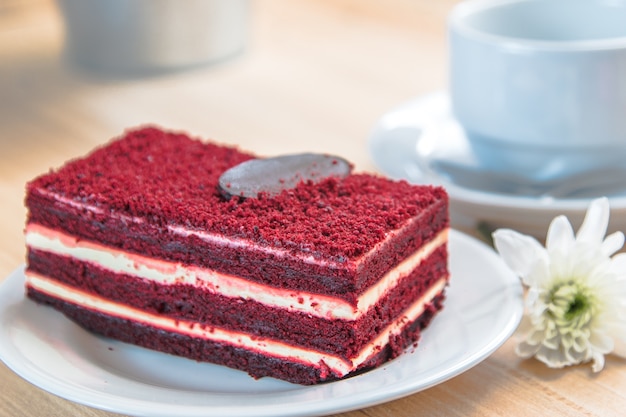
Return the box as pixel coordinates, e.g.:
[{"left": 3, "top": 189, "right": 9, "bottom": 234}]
[{"left": 0, "top": 229, "right": 523, "bottom": 417}]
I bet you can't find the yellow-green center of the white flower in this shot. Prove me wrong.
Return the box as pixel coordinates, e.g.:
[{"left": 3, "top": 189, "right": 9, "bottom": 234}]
[{"left": 548, "top": 280, "right": 593, "bottom": 329}]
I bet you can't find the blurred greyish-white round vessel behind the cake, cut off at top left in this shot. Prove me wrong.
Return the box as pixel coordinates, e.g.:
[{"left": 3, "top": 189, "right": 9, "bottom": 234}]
[{"left": 57, "top": 0, "right": 249, "bottom": 75}]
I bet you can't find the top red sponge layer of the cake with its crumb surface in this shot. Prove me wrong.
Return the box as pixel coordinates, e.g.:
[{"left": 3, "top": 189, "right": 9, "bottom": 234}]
[{"left": 26, "top": 128, "right": 448, "bottom": 299}]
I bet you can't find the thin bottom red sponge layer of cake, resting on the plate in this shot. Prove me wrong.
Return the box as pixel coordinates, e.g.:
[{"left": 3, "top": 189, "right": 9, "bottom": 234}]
[{"left": 29, "top": 290, "right": 442, "bottom": 385}]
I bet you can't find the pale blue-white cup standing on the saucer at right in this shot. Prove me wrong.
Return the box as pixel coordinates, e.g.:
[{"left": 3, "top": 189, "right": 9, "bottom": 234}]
[{"left": 449, "top": 0, "right": 626, "bottom": 178}]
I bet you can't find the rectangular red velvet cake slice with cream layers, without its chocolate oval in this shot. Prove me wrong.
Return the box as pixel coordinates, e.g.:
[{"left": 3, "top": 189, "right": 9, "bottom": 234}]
[{"left": 25, "top": 126, "right": 449, "bottom": 385}]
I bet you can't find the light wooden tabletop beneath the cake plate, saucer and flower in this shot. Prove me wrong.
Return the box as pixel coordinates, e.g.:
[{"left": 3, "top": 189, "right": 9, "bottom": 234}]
[{"left": 0, "top": 0, "right": 626, "bottom": 417}]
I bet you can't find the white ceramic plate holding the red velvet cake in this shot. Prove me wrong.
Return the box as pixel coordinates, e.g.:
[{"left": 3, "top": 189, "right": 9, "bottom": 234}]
[{"left": 0, "top": 230, "right": 523, "bottom": 417}]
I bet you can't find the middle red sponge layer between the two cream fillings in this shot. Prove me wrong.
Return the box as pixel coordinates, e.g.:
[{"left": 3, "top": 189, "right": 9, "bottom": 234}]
[{"left": 28, "top": 246, "right": 447, "bottom": 358}]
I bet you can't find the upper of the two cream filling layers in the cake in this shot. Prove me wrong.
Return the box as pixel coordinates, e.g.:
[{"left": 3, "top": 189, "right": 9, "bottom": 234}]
[{"left": 26, "top": 223, "right": 448, "bottom": 320}]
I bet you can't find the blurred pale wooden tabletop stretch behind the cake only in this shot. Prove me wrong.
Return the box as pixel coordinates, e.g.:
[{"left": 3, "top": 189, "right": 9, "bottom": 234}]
[{"left": 0, "top": 0, "right": 457, "bottom": 282}]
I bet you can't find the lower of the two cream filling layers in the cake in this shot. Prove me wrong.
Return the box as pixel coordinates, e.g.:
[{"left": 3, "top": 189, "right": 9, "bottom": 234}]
[{"left": 26, "top": 272, "right": 447, "bottom": 377}]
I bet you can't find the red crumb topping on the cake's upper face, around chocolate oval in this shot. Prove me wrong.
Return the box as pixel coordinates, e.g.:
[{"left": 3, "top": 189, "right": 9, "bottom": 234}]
[{"left": 28, "top": 127, "right": 447, "bottom": 260}]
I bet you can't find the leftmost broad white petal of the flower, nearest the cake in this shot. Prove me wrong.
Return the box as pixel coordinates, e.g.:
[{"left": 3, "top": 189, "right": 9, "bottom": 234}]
[{"left": 493, "top": 229, "right": 547, "bottom": 277}]
